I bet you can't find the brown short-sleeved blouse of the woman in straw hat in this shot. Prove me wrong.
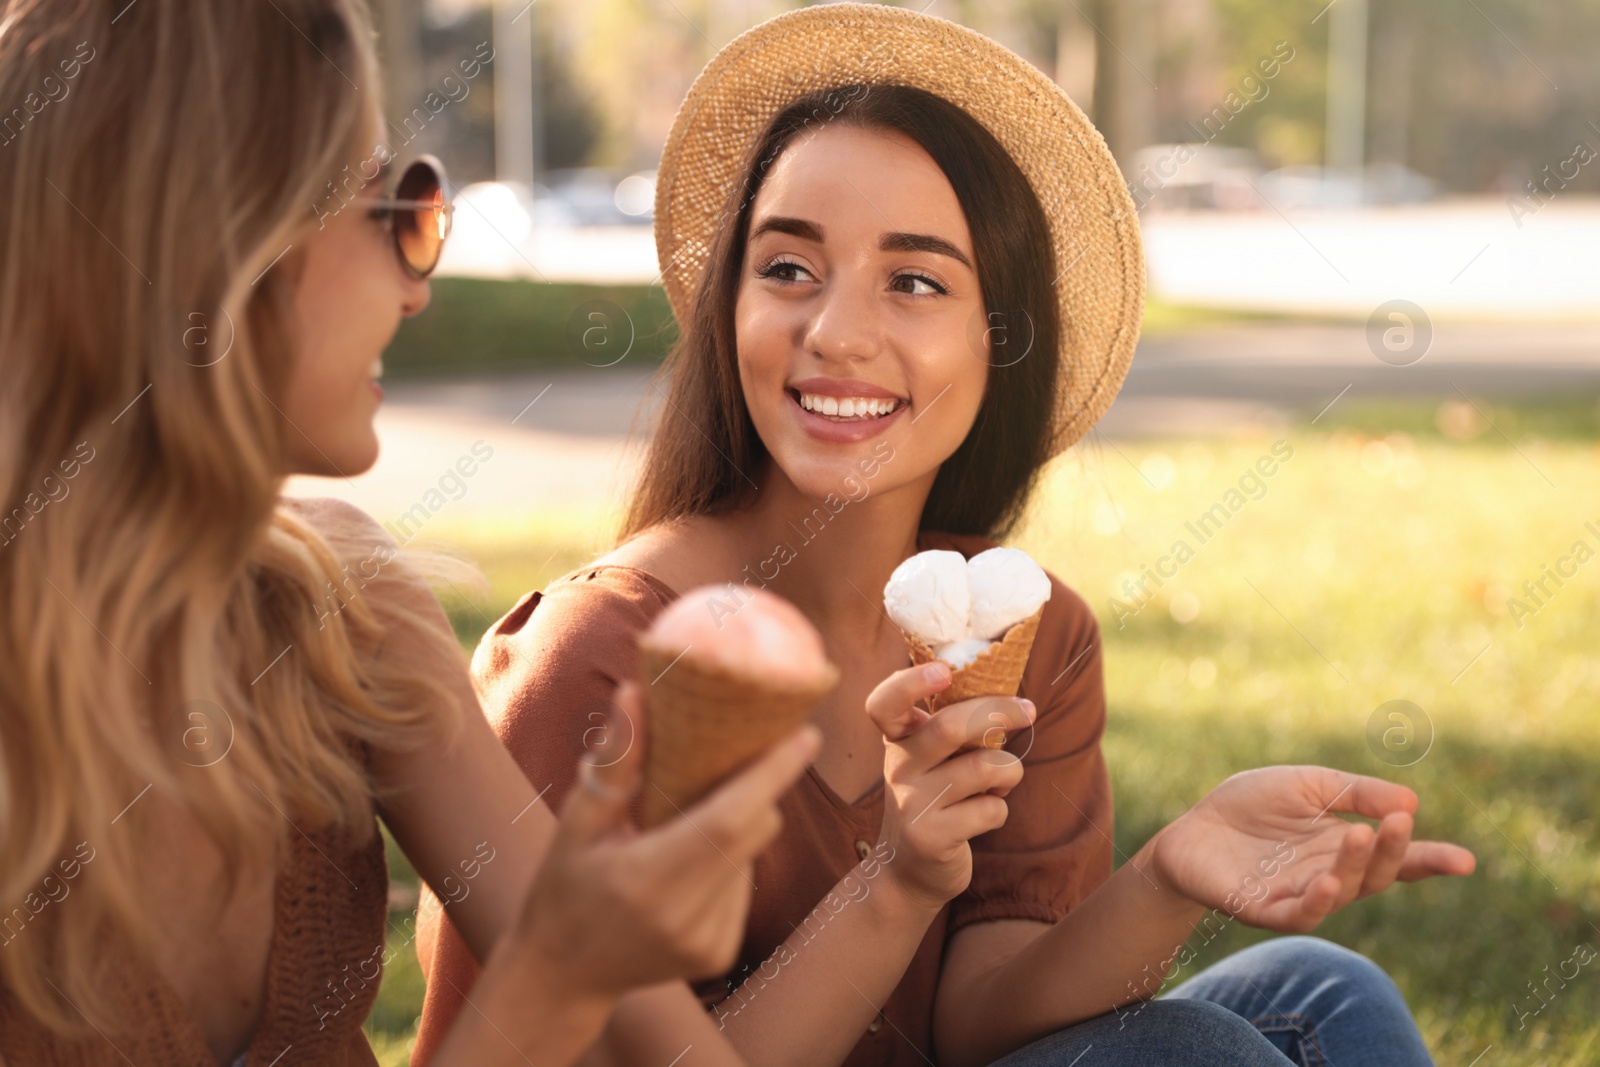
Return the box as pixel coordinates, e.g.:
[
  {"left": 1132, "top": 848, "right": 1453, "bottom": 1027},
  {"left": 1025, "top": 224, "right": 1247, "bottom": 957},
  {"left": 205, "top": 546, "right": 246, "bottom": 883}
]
[{"left": 411, "top": 533, "right": 1112, "bottom": 1067}]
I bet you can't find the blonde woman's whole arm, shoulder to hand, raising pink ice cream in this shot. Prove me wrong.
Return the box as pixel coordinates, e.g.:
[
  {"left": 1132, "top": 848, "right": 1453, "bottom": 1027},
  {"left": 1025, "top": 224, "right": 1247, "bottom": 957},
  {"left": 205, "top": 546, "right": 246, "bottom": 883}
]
[{"left": 302, "top": 502, "right": 814, "bottom": 1067}]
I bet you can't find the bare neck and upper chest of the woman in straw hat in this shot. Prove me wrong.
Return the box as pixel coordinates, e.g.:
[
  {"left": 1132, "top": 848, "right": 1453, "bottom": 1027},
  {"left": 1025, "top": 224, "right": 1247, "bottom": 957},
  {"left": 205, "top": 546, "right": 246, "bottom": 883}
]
[{"left": 720, "top": 461, "right": 933, "bottom": 640}]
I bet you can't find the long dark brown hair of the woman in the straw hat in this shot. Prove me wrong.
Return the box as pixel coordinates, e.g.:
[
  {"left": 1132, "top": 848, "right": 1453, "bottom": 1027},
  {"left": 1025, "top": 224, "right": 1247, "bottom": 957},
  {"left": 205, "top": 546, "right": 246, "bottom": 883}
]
[{"left": 622, "top": 85, "right": 1061, "bottom": 539}]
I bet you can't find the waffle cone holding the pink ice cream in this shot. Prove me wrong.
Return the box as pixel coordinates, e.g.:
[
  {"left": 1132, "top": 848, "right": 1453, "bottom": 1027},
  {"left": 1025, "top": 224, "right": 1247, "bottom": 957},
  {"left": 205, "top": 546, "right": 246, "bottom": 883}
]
[{"left": 638, "top": 641, "right": 838, "bottom": 830}]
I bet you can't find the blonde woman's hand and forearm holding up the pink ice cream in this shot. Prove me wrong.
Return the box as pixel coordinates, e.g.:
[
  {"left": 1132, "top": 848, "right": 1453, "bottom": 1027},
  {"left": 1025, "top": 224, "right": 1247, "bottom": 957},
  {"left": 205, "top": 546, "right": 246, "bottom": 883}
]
[{"left": 434, "top": 683, "right": 821, "bottom": 1067}]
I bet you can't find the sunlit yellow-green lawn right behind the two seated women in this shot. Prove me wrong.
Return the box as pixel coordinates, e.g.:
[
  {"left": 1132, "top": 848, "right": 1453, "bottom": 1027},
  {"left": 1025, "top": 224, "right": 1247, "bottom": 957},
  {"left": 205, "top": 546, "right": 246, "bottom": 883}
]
[{"left": 368, "top": 398, "right": 1600, "bottom": 1067}]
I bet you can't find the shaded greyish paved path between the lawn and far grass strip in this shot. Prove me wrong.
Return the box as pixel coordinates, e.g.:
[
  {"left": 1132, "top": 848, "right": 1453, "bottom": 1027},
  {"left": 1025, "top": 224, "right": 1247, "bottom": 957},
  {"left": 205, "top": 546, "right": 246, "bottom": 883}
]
[{"left": 290, "top": 323, "right": 1600, "bottom": 522}]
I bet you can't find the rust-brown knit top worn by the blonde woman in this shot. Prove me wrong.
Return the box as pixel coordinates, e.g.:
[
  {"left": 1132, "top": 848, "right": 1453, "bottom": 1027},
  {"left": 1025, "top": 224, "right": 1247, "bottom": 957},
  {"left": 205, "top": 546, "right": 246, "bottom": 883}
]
[{"left": 0, "top": 809, "right": 389, "bottom": 1067}]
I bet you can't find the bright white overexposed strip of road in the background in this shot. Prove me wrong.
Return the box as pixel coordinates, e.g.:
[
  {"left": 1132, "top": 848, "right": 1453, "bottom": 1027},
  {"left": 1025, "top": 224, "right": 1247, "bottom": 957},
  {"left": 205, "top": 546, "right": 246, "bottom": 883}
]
[{"left": 438, "top": 194, "right": 1600, "bottom": 322}]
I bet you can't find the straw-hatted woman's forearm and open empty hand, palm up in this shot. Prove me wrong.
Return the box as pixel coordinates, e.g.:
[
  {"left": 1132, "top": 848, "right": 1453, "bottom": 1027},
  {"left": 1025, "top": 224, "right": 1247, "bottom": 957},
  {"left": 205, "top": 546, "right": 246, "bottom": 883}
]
[{"left": 934, "top": 766, "right": 1474, "bottom": 1067}]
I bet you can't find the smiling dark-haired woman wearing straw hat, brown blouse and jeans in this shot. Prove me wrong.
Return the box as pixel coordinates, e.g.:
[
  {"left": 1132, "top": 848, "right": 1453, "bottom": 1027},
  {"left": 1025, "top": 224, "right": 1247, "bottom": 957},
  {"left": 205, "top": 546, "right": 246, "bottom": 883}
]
[{"left": 419, "top": 3, "right": 1474, "bottom": 1067}]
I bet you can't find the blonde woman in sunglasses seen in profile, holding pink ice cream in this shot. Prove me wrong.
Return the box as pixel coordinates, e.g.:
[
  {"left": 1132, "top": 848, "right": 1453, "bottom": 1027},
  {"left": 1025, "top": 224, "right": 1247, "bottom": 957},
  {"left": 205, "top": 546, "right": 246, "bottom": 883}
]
[{"left": 0, "top": 0, "right": 816, "bottom": 1067}]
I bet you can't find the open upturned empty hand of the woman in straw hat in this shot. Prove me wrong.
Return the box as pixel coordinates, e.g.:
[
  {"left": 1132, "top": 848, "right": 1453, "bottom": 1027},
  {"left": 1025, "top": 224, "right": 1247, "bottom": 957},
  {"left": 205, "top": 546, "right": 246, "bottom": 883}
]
[{"left": 1154, "top": 766, "right": 1477, "bottom": 933}]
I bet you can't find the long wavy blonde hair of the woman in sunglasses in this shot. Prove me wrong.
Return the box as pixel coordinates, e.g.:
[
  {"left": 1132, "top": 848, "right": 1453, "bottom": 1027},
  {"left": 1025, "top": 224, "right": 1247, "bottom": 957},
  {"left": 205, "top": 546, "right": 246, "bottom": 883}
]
[{"left": 0, "top": 0, "right": 459, "bottom": 1033}]
